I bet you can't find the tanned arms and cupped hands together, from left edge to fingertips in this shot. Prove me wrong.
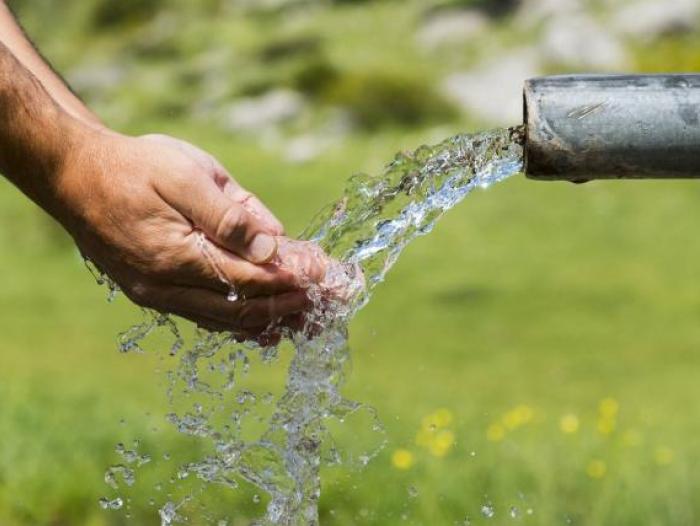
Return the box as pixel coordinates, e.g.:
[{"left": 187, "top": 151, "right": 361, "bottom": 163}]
[{"left": 0, "top": 4, "right": 322, "bottom": 338}]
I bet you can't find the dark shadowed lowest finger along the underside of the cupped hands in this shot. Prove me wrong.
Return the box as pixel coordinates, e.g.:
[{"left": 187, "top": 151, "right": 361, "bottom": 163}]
[{"left": 156, "top": 287, "right": 310, "bottom": 331}]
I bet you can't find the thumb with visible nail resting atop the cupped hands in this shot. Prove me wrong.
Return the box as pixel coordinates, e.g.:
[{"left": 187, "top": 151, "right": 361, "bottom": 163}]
[{"left": 158, "top": 171, "right": 277, "bottom": 263}]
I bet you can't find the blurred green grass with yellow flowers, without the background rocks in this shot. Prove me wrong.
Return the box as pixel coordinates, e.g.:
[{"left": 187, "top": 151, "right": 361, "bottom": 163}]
[{"left": 0, "top": 2, "right": 700, "bottom": 526}]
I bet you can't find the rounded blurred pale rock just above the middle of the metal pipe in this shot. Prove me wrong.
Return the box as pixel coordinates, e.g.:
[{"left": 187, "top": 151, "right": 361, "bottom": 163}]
[{"left": 539, "top": 14, "right": 628, "bottom": 71}]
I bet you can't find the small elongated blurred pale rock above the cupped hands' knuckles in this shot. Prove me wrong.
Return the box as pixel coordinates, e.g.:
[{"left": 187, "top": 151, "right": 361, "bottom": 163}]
[{"left": 221, "top": 89, "right": 306, "bottom": 132}]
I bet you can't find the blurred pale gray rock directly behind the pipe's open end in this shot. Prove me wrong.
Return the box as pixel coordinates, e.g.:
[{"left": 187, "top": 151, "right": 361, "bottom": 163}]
[{"left": 442, "top": 50, "right": 540, "bottom": 126}]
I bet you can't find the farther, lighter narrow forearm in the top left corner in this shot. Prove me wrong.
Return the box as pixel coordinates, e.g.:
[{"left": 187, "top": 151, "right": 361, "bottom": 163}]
[{"left": 0, "top": 0, "right": 102, "bottom": 127}]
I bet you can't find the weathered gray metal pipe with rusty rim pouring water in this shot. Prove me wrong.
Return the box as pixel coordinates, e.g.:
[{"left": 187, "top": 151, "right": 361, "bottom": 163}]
[{"left": 525, "top": 75, "right": 700, "bottom": 182}]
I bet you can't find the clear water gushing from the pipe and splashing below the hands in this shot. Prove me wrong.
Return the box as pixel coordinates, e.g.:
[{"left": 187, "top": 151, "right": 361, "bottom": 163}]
[{"left": 101, "top": 128, "right": 523, "bottom": 526}]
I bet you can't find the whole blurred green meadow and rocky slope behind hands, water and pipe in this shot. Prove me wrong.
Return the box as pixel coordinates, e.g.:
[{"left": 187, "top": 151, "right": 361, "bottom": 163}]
[{"left": 0, "top": 0, "right": 700, "bottom": 526}]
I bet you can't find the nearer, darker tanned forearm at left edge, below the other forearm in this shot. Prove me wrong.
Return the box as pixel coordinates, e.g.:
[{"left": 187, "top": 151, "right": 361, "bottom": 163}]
[{"left": 0, "top": 39, "right": 85, "bottom": 215}]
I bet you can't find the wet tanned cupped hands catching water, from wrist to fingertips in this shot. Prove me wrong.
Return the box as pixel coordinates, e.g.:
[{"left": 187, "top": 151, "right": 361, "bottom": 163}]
[{"left": 51, "top": 130, "right": 322, "bottom": 338}]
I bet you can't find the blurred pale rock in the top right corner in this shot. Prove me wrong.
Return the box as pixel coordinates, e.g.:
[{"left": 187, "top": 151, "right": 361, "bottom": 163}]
[{"left": 612, "top": 0, "right": 700, "bottom": 40}]
